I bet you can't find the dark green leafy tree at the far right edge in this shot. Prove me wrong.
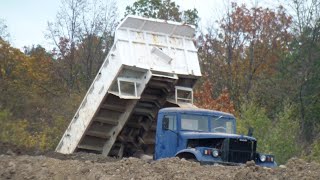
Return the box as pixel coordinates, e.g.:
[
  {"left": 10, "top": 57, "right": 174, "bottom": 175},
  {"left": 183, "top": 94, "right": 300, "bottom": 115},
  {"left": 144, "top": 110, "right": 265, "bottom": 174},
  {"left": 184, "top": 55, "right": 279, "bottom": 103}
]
[{"left": 280, "top": 21, "right": 320, "bottom": 143}]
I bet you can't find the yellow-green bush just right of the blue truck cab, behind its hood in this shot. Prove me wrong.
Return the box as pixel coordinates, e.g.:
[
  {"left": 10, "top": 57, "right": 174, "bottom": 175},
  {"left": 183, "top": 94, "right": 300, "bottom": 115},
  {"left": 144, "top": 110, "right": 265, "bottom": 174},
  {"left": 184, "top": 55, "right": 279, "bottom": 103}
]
[{"left": 238, "top": 103, "right": 301, "bottom": 164}]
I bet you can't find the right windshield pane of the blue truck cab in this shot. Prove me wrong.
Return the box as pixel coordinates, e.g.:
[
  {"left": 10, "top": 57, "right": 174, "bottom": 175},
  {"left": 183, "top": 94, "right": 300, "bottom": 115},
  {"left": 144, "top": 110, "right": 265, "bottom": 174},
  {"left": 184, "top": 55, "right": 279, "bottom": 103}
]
[{"left": 211, "top": 116, "right": 236, "bottom": 134}]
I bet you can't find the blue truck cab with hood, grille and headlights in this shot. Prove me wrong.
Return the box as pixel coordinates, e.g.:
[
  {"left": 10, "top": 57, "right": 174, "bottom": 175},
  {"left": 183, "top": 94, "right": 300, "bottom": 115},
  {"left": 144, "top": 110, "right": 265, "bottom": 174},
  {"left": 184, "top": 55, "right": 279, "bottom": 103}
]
[{"left": 154, "top": 108, "right": 277, "bottom": 167}]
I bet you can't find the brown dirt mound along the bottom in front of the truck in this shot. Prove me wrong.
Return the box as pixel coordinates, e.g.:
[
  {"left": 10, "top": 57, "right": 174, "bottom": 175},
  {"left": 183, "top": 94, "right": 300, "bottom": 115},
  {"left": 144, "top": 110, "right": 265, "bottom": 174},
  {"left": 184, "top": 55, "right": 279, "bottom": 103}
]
[{"left": 0, "top": 153, "right": 320, "bottom": 180}]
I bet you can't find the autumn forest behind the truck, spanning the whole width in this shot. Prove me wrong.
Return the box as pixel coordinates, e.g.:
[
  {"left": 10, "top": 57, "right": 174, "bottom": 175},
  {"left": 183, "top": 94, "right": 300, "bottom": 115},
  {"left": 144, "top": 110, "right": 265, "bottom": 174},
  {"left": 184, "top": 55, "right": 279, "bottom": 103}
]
[{"left": 0, "top": 0, "right": 320, "bottom": 164}]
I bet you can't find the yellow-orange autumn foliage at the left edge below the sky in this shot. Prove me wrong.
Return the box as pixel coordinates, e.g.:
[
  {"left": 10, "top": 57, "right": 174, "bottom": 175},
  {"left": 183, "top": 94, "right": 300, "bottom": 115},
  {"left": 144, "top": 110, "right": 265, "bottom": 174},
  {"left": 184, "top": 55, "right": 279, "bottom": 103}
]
[{"left": 0, "top": 41, "right": 54, "bottom": 97}]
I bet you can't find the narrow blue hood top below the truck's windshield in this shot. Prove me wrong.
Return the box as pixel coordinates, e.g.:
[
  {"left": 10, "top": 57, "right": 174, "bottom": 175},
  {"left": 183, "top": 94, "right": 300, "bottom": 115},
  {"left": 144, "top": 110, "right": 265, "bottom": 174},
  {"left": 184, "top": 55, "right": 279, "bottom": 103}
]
[{"left": 179, "top": 131, "right": 256, "bottom": 141}]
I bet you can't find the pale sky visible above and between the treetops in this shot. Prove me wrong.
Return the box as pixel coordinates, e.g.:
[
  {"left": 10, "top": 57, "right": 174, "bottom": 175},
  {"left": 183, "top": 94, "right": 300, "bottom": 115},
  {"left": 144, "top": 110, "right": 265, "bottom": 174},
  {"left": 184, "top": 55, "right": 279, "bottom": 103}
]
[{"left": 0, "top": 0, "right": 280, "bottom": 49}]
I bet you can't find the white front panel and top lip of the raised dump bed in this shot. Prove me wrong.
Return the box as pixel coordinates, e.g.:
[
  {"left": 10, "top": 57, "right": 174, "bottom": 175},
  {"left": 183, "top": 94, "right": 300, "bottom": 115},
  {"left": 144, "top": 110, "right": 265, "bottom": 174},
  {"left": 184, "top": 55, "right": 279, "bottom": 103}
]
[{"left": 115, "top": 16, "right": 201, "bottom": 76}]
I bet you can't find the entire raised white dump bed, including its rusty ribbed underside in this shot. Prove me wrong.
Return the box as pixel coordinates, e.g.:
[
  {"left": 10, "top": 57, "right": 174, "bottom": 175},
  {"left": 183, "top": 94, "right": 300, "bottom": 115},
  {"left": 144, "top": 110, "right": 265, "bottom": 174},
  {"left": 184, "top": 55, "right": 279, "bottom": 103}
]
[{"left": 56, "top": 16, "right": 201, "bottom": 157}]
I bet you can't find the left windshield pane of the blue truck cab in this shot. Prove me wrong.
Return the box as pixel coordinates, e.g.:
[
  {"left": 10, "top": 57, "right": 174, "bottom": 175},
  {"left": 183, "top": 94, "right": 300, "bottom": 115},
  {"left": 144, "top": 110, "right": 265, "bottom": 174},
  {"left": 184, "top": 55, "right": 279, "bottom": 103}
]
[{"left": 181, "top": 114, "right": 209, "bottom": 132}]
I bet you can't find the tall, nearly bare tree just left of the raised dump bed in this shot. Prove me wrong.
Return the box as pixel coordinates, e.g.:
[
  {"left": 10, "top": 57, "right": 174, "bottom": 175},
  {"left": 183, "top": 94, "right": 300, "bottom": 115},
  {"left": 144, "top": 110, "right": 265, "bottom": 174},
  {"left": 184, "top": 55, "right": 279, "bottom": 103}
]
[{"left": 47, "top": 0, "right": 117, "bottom": 90}]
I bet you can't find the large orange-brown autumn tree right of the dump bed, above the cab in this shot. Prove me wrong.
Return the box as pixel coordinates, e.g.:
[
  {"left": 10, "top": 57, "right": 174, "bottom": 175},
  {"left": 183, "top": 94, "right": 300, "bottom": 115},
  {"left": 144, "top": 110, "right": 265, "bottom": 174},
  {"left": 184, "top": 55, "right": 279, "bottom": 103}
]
[{"left": 199, "top": 3, "right": 291, "bottom": 109}]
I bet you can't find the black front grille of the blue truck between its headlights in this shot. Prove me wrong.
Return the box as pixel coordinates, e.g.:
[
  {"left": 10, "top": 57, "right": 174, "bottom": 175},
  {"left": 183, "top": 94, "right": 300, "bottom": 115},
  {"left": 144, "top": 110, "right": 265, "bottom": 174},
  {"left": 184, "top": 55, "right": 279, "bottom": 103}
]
[{"left": 222, "top": 139, "right": 256, "bottom": 163}]
